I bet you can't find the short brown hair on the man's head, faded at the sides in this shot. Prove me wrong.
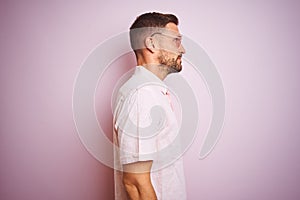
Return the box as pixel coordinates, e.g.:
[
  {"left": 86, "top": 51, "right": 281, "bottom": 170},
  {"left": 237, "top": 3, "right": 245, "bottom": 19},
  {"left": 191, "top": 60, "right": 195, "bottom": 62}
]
[{"left": 129, "top": 12, "right": 179, "bottom": 52}]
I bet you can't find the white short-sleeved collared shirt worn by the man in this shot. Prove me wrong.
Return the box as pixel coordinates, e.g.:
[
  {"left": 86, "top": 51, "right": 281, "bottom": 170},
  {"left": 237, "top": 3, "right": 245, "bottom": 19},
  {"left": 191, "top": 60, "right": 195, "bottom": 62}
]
[{"left": 113, "top": 66, "right": 186, "bottom": 200}]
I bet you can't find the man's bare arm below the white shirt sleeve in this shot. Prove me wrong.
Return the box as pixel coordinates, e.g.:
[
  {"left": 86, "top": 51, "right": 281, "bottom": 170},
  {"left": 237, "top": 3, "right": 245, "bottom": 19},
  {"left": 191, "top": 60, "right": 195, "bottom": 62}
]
[{"left": 123, "top": 161, "right": 157, "bottom": 200}]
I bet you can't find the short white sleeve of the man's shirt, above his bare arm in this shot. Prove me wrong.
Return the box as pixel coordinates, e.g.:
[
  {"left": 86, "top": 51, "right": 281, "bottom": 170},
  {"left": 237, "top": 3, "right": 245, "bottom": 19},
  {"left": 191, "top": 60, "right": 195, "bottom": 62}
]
[{"left": 115, "top": 88, "right": 165, "bottom": 164}]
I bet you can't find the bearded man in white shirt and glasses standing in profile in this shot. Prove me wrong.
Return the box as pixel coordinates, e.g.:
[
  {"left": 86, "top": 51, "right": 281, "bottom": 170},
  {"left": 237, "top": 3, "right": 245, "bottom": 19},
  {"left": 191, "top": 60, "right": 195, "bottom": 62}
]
[{"left": 114, "top": 13, "right": 186, "bottom": 200}]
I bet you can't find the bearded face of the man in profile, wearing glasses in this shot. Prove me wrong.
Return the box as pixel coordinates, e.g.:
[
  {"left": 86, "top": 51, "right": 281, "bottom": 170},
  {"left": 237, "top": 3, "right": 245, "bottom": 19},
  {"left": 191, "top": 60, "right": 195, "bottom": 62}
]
[{"left": 157, "top": 23, "right": 185, "bottom": 73}]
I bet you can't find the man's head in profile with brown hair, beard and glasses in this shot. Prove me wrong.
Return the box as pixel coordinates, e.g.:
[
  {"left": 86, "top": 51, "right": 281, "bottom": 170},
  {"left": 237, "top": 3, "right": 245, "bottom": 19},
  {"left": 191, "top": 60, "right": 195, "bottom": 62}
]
[{"left": 130, "top": 12, "right": 185, "bottom": 74}]
